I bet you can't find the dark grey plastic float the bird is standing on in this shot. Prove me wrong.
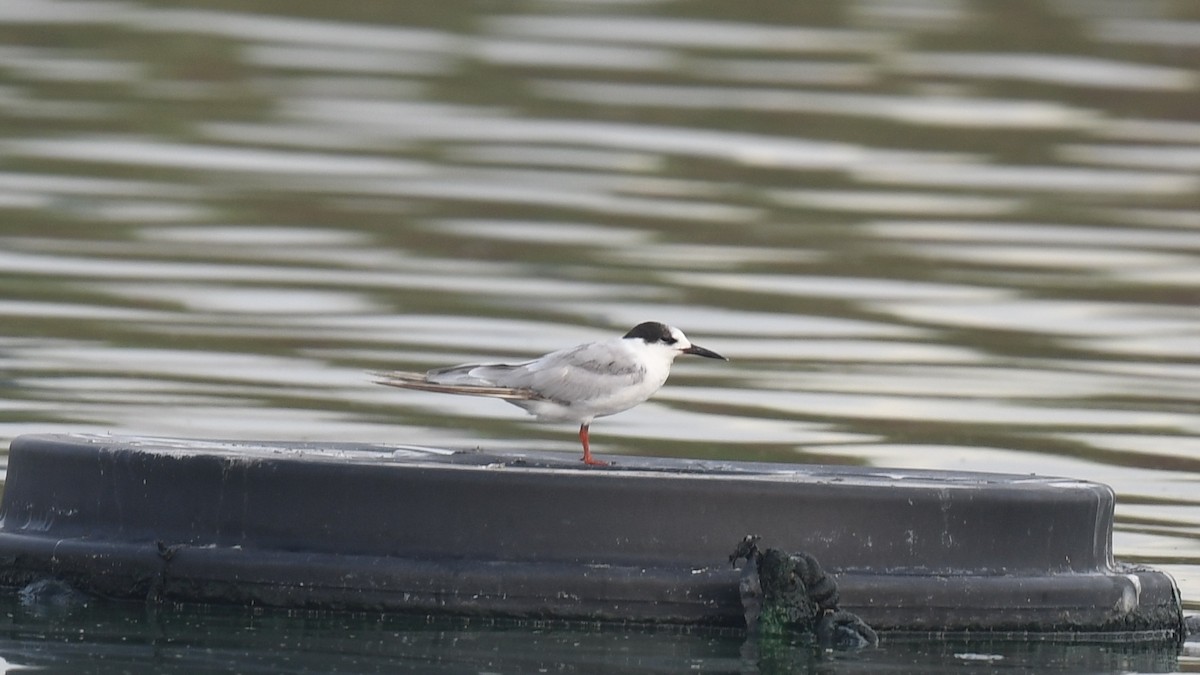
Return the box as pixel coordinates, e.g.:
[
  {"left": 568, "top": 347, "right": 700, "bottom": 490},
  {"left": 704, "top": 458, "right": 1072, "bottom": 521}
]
[{"left": 0, "top": 435, "right": 1183, "bottom": 640}]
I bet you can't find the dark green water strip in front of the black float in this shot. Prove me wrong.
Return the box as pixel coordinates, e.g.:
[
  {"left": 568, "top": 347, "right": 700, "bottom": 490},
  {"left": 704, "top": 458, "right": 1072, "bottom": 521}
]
[{"left": 0, "top": 593, "right": 1187, "bottom": 674}]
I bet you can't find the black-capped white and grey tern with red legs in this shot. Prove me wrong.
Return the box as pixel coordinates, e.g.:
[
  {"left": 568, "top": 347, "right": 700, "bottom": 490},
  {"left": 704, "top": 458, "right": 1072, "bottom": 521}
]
[{"left": 374, "top": 321, "right": 728, "bottom": 466}]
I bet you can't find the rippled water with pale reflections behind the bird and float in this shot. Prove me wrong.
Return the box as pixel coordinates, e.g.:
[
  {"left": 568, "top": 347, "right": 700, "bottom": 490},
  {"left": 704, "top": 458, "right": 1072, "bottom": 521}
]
[{"left": 0, "top": 0, "right": 1200, "bottom": 668}]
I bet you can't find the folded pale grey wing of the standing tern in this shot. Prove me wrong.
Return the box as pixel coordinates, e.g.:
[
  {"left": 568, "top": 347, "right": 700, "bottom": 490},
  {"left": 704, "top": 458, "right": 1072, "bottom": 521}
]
[{"left": 486, "top": 341, "right": 646, "bottom": 405}]
